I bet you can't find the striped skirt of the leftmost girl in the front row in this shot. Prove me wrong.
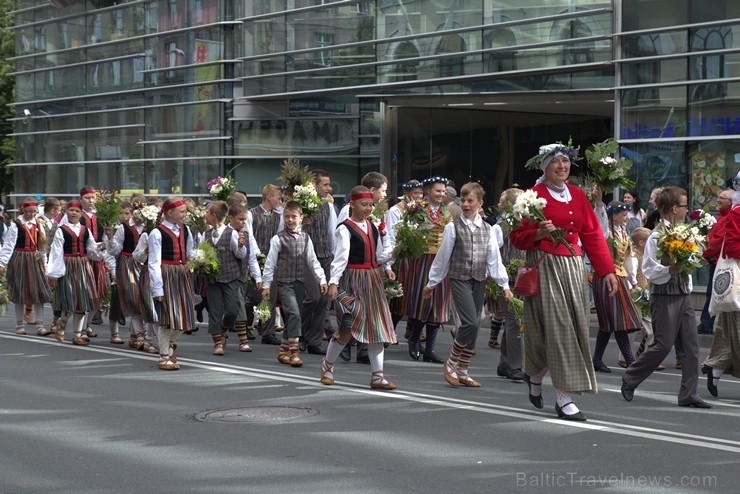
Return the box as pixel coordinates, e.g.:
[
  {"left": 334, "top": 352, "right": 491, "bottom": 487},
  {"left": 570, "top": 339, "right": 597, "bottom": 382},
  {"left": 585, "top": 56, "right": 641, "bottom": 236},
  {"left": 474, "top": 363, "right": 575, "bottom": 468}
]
[{"left": 5, "top": 250, "right": 51, "bottom": 304}]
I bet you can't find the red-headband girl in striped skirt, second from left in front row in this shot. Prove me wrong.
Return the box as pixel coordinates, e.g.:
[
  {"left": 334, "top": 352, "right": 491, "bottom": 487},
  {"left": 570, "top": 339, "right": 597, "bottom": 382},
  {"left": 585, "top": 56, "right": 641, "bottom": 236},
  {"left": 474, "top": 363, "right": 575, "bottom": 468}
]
[{"left": 47, "top": 201, "right": 102, "bottom": 346}]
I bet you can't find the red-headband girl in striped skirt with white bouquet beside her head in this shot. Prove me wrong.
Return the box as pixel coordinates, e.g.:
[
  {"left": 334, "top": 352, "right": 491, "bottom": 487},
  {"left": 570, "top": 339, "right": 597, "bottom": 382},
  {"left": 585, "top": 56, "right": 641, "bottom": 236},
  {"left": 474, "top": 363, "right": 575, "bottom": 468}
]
[{"left": 148, "top": 197, "right": 195, "bottom": 370}]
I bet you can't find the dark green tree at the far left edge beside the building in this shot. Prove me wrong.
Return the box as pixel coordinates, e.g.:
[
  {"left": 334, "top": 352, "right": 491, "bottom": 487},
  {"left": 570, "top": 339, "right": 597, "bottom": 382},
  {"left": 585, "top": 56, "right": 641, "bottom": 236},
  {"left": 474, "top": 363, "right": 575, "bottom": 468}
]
[{"left": 0, "top": 0, "right": 15, "bottom": 200}]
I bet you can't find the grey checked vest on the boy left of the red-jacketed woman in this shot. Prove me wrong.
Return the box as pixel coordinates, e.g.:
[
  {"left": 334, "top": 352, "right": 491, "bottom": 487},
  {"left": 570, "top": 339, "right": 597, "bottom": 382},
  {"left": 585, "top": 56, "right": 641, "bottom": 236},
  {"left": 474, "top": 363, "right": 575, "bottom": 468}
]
[{"left": 447, "top": 217, "right": 491, "bottom": 281}]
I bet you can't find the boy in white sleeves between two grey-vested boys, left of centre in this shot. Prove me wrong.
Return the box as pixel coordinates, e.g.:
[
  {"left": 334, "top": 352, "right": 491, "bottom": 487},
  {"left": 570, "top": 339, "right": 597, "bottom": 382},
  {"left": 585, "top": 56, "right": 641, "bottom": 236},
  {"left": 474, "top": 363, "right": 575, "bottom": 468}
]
[{"left": 229, "top": 205, "right": 262, "bottom": 352}]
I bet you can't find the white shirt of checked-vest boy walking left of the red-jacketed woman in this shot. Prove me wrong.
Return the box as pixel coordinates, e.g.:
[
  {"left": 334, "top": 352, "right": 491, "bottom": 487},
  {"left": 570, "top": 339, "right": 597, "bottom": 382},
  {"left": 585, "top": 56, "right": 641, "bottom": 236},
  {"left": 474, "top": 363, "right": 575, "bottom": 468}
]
[{"left": 427, "top": 214, "right": 509, "bottom": 290}]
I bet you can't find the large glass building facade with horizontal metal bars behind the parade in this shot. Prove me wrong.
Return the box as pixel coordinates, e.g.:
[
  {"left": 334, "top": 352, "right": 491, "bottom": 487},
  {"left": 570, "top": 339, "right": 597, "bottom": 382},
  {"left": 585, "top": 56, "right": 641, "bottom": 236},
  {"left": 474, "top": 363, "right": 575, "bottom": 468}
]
[{"left": 12, "top": 0, "right": 740, "bottom": 213}]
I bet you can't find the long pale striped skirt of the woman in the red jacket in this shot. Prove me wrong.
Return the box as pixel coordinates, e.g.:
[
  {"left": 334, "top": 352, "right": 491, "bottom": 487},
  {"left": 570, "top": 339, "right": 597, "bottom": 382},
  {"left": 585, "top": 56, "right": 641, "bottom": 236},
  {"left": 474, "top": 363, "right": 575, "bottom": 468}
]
[{"left": 522, "top": 250, "right": 596, "bottom": 393}]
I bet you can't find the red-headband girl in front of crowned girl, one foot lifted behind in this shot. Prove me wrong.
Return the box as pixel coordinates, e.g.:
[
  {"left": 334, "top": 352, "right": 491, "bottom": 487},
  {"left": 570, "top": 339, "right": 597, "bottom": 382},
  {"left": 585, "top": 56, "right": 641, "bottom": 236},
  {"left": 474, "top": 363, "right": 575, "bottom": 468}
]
[{"left": 321, "top": 185, "right": 396, "bottom": 390}]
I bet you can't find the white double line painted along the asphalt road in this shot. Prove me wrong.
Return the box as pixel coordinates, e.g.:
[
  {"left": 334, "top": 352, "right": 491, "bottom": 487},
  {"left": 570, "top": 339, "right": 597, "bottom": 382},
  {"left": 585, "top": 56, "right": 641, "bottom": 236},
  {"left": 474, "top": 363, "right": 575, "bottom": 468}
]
[{"left": 0, "top": 332, "right": 740, "bottom": 453}]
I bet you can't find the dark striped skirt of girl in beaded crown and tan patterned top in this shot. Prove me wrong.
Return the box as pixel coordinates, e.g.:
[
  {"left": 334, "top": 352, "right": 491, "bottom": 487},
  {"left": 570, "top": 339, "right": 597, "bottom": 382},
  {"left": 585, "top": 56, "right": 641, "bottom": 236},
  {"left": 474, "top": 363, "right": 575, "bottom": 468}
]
[{"left": 394, "top": 254, "right": 452, "bottom": 324}]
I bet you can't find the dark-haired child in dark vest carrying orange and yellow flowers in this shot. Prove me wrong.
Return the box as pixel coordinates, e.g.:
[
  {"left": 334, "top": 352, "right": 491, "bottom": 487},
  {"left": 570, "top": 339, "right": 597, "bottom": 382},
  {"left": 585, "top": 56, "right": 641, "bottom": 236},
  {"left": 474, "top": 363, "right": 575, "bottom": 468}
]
[{"left": 622, "top": 186, "right": 712, "bottom": 408}]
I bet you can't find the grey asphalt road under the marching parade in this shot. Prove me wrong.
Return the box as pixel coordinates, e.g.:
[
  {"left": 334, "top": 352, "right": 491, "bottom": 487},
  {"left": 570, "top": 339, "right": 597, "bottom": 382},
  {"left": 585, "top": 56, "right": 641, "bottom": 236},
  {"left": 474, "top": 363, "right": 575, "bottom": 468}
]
[{"left": 0, "top": 315, "right": 740, "bottom": 493}]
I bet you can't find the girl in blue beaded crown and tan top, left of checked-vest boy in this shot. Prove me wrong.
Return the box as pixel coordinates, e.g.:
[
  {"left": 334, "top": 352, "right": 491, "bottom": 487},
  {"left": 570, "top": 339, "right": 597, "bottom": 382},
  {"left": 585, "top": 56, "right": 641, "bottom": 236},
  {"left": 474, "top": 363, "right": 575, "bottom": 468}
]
[{"left": 398, "top": 177, "right": 452, "bottom": 364}]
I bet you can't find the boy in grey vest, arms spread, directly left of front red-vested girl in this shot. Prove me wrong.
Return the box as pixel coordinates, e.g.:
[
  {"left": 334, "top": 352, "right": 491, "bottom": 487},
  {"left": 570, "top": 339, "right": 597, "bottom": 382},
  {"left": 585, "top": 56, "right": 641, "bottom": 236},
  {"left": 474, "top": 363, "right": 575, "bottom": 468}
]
[{"left": 262, "top": 201, "right": 328, "bottom": 367}]
